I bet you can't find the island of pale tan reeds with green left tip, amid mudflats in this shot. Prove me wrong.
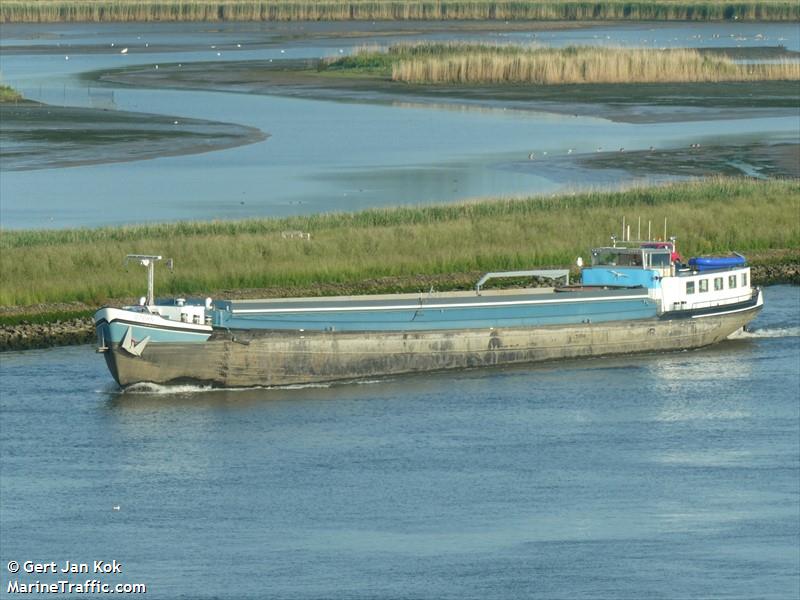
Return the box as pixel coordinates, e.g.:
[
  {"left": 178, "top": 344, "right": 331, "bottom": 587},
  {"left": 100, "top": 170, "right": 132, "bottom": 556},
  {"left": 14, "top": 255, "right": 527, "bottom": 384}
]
[{"left": 324, "top": 43, "right": 800, "bottom": 85}]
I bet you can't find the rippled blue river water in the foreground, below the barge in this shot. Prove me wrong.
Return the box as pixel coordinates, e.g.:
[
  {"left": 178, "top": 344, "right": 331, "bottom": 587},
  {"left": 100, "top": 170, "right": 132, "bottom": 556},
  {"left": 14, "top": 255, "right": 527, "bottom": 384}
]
[{"left": 0, "top": 286, "right": 800, "bottom": 600}]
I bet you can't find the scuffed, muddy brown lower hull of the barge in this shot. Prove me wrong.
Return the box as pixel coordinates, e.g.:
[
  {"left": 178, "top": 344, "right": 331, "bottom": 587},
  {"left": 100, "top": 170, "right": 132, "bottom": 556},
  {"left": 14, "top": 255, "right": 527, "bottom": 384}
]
[{"left": 104, "top": 301, "right": 761, "bottom": 387}]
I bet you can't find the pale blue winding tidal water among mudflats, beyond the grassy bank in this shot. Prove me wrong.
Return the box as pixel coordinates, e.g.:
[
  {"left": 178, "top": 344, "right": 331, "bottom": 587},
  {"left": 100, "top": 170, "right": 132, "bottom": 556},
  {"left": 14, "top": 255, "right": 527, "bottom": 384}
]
[{"left": 0, "top": 23, "right": 800, "bottom": 229}]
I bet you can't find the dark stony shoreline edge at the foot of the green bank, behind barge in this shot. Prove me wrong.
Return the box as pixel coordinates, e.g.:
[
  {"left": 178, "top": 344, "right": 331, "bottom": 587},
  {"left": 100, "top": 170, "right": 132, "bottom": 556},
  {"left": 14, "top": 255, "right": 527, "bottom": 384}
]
[{"left": 0, "top": 261, "right": 800, "bottom": 352}]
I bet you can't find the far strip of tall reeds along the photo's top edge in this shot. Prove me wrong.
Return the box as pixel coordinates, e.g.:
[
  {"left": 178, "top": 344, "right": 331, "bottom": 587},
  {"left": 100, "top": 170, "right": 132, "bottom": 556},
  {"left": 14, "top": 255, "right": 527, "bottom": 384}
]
[{"left": 0, "top": 0, "right": 800, "bottom": 23}]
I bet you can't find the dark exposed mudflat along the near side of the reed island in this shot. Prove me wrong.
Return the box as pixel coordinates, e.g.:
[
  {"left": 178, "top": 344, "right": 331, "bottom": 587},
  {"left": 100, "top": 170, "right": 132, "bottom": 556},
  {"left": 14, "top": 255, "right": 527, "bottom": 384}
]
[{"left": 97, "top": 60, "right": 800, "bottom": 123}]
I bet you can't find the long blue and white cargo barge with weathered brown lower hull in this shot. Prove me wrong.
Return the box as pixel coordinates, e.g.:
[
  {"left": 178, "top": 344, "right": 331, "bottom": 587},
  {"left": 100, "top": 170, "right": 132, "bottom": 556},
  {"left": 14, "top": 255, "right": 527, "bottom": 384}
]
[{"left": 94, "top": 236, "right": 763, "bottom": 387}]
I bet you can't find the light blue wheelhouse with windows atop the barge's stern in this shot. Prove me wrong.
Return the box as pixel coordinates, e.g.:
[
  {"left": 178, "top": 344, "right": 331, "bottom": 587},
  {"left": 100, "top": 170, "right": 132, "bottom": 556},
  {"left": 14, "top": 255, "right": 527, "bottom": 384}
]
[{"left": 582, "top": 242, "right": 675, "bottom": 289}]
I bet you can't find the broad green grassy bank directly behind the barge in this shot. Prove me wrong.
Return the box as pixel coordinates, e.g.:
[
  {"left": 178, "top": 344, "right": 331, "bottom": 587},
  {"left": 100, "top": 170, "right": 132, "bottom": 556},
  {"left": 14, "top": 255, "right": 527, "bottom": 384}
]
[{"left": 0, "top": 179, "right": 800, "bottom": 306}]
